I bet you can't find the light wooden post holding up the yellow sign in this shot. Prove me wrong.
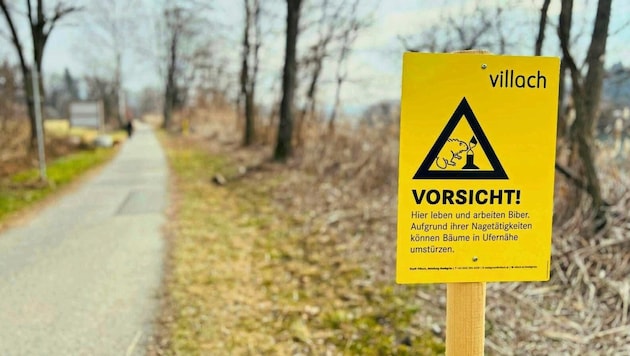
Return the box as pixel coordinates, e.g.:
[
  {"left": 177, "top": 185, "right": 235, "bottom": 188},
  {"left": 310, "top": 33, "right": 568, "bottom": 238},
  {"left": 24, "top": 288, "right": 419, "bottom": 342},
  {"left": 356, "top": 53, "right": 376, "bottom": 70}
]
[{"left": 446, "top": 282, "right": 486, "bottom": 356}]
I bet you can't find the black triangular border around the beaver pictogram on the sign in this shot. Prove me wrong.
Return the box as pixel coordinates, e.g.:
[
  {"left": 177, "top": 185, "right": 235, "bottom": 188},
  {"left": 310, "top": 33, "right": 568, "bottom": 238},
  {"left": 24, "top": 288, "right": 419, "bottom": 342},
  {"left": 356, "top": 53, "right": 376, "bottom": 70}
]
[{"left": 413, "top": 97, "right": 508, "bottom": 179}]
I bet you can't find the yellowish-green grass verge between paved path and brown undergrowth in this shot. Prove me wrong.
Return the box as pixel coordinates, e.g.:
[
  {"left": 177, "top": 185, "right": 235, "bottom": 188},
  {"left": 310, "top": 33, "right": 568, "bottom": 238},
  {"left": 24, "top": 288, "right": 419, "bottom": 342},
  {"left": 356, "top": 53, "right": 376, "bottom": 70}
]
[{"left": 153, "top": 137, "right": 444, "bottom": 355}]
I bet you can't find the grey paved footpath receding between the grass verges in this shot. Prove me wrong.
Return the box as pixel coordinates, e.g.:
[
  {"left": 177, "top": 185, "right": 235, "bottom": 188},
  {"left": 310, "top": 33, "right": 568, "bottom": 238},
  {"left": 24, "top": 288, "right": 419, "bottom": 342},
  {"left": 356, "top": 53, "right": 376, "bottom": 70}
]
[{"left": 0, "top": 123, "right": 167, "bottom": 356}]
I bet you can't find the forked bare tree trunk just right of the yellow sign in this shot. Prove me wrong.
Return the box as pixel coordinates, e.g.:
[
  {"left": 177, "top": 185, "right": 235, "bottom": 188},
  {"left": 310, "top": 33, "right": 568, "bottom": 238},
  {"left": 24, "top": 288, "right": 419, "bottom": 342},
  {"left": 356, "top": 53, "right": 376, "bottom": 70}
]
[{"left": 558, "top": 0, "right": 612, "bottom": 228}]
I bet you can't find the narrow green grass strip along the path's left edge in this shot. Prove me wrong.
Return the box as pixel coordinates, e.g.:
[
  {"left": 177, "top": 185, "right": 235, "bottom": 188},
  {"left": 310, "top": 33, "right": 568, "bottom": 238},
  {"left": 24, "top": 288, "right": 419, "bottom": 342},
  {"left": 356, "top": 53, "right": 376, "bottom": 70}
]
[{"left": 0, "top": 148, "right": 117, "bottom": 223}]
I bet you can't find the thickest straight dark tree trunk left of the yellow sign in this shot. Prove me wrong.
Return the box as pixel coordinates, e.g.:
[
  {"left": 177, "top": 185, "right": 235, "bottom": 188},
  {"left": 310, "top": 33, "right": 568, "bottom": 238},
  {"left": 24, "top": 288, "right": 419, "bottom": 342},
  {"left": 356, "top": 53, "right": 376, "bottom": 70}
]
[{"left": 274, "top": 0, "right": 302, "bottom": 161}]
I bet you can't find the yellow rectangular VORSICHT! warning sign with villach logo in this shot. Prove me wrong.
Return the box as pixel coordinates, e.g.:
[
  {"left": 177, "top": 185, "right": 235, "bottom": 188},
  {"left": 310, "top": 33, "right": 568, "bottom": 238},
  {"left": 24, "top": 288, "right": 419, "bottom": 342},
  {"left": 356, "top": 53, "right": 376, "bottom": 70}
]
[{"left": 396, "top": 53, "right": 560, "bottom": 283}]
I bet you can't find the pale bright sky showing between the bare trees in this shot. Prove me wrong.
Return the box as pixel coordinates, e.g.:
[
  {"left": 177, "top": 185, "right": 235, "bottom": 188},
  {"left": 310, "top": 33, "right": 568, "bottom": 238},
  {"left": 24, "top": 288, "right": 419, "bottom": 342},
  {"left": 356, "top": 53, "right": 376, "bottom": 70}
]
[{"left": 0, "top": 0, "right": 630, "bottom": 111}]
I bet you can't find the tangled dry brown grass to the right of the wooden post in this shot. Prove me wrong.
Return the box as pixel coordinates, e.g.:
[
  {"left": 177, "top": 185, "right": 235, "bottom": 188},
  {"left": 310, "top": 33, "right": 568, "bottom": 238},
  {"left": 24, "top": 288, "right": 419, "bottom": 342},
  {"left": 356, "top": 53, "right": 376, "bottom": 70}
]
[{"left": 487, "top": 152, "right": 630, "bottom": 355}]
